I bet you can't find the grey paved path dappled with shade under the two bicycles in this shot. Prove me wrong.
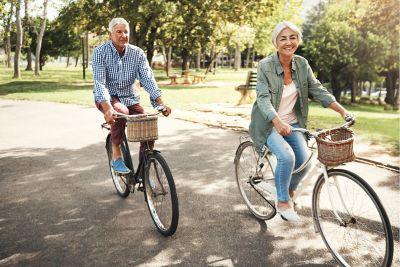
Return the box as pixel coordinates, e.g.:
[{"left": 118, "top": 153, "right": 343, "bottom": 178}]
[{"left": 0, "top": 100, "right": 400, "bottom": 266}]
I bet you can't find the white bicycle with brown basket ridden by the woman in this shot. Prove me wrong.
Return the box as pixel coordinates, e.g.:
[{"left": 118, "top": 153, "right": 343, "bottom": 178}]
[{"left": 234, "top": 118, "right": 394, "bottom": 266}]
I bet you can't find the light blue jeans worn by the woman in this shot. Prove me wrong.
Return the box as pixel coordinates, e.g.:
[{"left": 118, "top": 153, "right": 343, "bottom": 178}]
[{"left": 266, "top": 123, "right": 308, "bottom": 202}]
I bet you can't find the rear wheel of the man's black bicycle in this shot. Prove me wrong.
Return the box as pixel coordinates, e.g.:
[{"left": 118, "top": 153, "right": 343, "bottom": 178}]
[{"left": 106, "top": 134, "right": 133, "bottom": 198}]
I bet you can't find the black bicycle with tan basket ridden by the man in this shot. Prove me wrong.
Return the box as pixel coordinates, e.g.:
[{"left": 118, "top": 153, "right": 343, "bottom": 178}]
[{"left": 101, "top": 106, "right": 179, "bottom": 236}]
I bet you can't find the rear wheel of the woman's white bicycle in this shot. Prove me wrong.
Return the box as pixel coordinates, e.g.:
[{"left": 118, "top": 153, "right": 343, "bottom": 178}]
[{"left": 235, "top": 141, "right": 276, "bottom": 220}]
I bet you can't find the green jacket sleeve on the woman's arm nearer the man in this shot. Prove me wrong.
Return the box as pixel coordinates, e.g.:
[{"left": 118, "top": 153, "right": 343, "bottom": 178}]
[{"left": 256, "top": 62, "right": 278, "bottom": 121}]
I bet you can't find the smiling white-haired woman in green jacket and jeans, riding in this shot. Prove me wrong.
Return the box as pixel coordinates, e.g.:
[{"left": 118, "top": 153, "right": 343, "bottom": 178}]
[{"left": 249, "top": 21, "right": 351, "bottom": 223}]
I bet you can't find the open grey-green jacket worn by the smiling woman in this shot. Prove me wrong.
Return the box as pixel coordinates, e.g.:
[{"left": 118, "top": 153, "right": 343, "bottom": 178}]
[{"left": 249, "top": 53, "right": 335, "bottom": 152}]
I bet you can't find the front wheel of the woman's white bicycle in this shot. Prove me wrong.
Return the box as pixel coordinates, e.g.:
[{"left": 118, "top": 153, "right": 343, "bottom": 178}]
[{"left": 312, "top": 169, "right": 393, "bottom": 266}]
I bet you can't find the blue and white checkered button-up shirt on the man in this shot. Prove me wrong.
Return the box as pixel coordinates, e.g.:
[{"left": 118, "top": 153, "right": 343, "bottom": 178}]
[{"left": 92, "top": 41, "right": 161, "bottom": 106}]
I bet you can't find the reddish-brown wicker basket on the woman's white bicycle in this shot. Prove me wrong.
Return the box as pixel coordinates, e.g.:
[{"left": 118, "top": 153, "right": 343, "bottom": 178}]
[{"left": 316, "top": 128, "right": 355, "bottom": 166}]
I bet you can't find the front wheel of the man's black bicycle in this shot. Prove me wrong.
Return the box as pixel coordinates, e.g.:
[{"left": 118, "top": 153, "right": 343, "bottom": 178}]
[{"left": 144, "top": 153, "right": 179, "bottom": 236}]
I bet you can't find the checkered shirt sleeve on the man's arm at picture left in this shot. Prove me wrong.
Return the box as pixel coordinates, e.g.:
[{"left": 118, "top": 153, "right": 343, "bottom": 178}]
[{"left": 92, "top": 48, "right": 111, "bottom": 102}]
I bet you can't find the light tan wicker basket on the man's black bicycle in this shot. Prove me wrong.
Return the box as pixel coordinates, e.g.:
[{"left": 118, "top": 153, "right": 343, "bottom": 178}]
[{"left": 127, "top": 116, "right": 158, "bottom": 142}]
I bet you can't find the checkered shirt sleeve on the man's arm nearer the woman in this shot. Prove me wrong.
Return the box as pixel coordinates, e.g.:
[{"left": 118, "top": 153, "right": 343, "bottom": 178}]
[{"left": 138, "top": 51, "right": 161, "bottom": 107}]
